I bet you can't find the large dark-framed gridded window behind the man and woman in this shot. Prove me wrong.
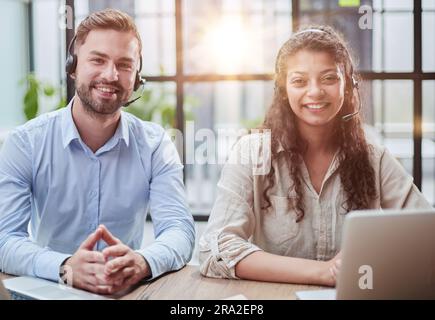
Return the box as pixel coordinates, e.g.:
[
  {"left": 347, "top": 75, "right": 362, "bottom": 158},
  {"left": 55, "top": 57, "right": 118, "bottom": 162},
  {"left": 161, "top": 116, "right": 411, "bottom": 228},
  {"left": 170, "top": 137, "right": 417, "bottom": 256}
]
[{"left": 58, "top": 0, "right": 435, "bottom": 212}]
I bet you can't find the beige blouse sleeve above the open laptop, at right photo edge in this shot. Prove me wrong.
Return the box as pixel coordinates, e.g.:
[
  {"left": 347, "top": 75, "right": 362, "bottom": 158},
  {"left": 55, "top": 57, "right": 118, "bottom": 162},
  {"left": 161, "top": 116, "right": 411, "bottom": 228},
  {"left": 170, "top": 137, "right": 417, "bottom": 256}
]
[{"left": 380, "top": 148, "right": 433, "bottom": 209}]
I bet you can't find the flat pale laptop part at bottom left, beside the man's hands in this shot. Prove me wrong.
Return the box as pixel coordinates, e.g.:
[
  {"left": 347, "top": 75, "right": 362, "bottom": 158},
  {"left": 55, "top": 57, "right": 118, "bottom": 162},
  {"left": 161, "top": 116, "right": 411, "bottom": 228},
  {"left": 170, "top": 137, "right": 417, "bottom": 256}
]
[{"left": 0, "top": 277, "right": 112, "bottom": 300}]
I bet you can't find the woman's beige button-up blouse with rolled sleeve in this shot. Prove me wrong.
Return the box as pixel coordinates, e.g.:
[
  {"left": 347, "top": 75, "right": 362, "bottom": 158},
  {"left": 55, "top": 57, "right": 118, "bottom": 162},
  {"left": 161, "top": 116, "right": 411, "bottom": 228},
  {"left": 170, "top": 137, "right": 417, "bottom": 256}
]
[{"left": 199, "top": 134, "right": 432, "bottom": 279}]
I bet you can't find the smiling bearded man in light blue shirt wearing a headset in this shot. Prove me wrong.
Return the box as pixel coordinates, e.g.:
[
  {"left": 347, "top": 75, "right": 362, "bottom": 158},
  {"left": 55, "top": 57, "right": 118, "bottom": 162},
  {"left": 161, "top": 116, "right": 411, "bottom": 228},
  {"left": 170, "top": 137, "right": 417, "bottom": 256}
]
[{"left": 0, "top": 9, "right": 195, "bottom": 294}]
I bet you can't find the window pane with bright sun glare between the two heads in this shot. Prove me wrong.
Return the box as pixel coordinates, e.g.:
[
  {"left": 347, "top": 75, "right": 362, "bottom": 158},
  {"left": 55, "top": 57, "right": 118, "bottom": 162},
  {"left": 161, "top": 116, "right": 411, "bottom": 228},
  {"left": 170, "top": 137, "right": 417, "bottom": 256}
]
[{"left": 183, "top": 0, "right": 291, "bottom": 74}]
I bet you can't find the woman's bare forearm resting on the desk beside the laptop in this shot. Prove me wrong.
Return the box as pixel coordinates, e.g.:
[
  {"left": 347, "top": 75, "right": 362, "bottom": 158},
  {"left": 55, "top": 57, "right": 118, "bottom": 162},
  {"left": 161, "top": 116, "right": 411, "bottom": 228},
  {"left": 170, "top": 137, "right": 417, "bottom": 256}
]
[{"left": 236, "top": 251, "right": 335, "bottom": 286}]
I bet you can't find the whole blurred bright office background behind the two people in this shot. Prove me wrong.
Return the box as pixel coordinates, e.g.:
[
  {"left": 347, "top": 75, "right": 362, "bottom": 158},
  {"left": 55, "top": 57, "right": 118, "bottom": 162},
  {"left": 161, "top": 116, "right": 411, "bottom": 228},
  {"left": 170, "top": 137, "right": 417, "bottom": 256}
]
[{"left": 0, "top": 0, "right": 435, "bottom": 221}]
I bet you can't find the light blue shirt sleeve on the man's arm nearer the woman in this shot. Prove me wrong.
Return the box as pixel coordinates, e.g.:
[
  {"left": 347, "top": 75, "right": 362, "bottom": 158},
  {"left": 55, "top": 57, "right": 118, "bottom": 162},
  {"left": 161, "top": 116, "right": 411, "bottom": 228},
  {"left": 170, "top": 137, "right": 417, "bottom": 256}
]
[{"left": 137, "top": 130, "right": 195, "bottom": 279}]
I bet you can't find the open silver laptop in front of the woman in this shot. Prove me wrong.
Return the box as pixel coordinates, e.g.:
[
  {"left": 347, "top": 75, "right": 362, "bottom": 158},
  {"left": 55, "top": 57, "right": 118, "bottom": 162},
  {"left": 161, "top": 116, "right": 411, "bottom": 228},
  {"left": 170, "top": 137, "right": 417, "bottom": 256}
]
[{"left": 296, "top": 209, "right": 435, "bottom": 300}]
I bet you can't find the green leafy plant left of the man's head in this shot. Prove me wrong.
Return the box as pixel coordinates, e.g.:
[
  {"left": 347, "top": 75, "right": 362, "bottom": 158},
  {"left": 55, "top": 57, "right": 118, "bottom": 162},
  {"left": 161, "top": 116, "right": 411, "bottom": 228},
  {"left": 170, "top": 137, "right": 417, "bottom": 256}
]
[{"left": 20, "top": 73, "right": 66, "bottom": 120}]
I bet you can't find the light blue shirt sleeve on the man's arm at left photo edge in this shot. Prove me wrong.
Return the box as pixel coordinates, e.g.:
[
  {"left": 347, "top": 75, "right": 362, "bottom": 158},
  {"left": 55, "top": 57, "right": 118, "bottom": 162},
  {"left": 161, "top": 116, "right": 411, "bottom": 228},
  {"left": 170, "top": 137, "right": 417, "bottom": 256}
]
[{"left": 0, "top": 131, "right": 69, "bottom": 281}]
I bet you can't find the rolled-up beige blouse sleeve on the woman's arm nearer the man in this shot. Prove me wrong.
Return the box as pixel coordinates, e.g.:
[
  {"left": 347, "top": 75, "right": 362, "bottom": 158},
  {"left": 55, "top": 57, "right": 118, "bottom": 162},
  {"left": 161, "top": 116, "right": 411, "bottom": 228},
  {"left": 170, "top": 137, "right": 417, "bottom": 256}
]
[{"left": 199, "top": 136, "right": 261, "bottom": 279}]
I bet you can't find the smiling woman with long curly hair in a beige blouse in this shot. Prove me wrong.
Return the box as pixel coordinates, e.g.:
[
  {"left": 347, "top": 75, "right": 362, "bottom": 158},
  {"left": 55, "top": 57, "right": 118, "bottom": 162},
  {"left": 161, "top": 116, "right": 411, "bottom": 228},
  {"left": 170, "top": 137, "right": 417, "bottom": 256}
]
[{"left": 200, "top": 26, "right": 431, "bottom": 286}]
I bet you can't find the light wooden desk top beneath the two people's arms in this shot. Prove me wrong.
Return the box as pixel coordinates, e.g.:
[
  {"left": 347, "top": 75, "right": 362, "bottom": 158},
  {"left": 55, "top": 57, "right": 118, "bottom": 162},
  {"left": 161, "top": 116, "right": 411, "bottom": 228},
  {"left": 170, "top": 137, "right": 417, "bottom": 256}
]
[{"left": 0, "top": 265, "right": 325, "bottom": 300}]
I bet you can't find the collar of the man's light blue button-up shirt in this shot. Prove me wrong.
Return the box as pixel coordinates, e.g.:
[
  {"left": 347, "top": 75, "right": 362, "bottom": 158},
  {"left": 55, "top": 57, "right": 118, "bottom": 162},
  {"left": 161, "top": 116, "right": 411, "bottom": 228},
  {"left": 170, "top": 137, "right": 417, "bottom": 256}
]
[{"left": 62, "top": 99, "right": 130, "bottom": 148}]
